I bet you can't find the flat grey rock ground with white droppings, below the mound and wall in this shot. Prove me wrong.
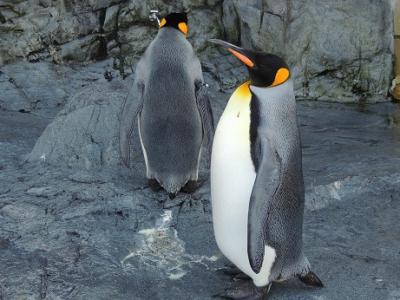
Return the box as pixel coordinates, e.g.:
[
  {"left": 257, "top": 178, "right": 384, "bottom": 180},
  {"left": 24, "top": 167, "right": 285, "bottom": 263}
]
[{"left": 0, "top": 97, "right": 400, "bottom": 300}]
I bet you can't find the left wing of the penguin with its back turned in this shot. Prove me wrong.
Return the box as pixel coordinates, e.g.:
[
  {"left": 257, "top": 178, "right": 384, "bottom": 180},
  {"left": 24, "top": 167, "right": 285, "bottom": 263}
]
[{"left": 119, "top": 82, "right": 144, "bottom": 167}]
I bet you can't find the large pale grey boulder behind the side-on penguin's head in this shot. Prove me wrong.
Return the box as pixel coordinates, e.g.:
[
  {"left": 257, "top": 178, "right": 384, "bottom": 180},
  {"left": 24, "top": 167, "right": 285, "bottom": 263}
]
[{"left": 223, "top": 0, "right": 393, "bottom": 101}]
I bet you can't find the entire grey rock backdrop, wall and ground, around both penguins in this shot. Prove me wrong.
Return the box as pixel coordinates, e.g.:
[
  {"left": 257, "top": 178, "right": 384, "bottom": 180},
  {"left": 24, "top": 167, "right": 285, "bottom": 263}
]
[{"left": 0, "top": 0, "right": 400, "bottom": 300}]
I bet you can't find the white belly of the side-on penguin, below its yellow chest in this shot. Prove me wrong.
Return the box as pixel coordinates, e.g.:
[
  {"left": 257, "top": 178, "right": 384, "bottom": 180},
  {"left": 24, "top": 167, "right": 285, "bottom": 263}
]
[{"left": 211, "top": 91, "right": 275, "bottom": 286}]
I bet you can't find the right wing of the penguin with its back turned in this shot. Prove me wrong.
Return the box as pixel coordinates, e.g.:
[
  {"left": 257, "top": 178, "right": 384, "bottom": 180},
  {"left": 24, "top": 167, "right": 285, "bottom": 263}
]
[{"left": 195, "top": 81, "right": 214, "bottom": 162}]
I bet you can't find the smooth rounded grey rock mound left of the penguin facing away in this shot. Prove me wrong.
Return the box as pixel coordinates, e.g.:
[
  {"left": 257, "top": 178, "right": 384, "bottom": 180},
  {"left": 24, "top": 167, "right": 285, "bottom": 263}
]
[{"left": 27, "top": 81, "right": 128, "bottom": 169}]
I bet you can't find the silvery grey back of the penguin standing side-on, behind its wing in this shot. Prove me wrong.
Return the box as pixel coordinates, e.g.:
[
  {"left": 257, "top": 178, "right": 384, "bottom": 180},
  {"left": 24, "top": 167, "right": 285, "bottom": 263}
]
[{"left": 251, "top": 80, "right": 309, "bottom": 280}]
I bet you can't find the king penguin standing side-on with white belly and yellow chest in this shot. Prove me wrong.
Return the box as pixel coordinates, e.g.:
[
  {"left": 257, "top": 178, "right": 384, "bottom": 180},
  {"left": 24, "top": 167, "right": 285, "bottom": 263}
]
[{"left": 210, "top": 39, "right": 322, "bottom": 299}]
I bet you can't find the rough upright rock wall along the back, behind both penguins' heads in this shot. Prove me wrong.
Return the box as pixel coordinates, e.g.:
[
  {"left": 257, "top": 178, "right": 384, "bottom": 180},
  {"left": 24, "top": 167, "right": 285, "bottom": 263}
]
[{"left": 0, "top": 0, "right": 393, "bottom": 102}]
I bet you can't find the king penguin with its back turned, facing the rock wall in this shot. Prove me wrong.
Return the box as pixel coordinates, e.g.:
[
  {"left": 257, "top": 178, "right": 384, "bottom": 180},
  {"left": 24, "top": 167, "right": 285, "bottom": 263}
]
[{"left": 120, "top": 13, "right": 214, "bottom": 197}]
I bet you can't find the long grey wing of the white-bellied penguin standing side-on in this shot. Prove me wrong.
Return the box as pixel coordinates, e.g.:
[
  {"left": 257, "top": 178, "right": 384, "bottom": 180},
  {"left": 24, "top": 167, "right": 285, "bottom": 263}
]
[{"left": 247, "top": 137, "right": 282, "bottom": 273}]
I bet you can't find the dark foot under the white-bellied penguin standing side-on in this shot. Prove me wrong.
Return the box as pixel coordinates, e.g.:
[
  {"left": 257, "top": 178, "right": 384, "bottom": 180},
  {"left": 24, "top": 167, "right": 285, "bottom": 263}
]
[{"left": 213, "top": 282, "right": 272, "bottom": 300}]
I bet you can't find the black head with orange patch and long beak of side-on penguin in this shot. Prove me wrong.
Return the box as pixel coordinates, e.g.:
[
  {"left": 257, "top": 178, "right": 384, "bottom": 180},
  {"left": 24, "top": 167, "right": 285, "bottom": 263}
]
[{"left": 210, "top": 39, "right": 290, "bottom": 87}]
